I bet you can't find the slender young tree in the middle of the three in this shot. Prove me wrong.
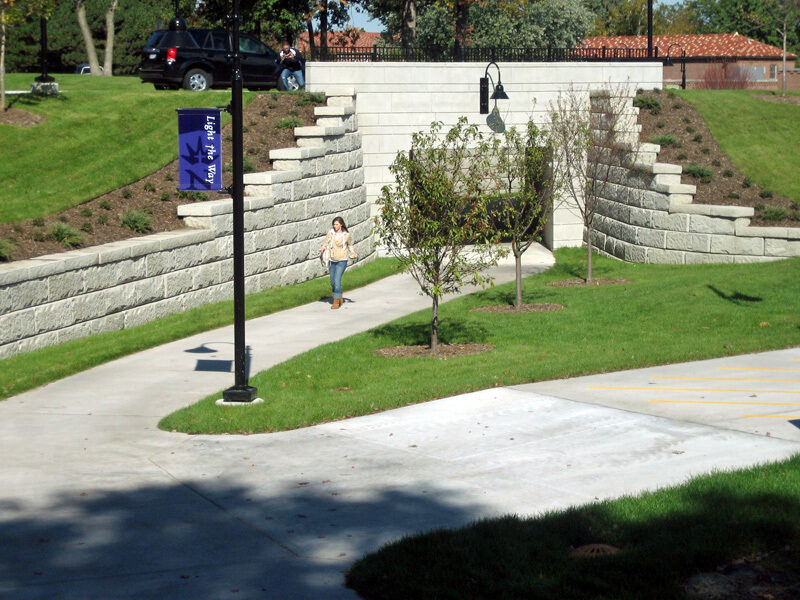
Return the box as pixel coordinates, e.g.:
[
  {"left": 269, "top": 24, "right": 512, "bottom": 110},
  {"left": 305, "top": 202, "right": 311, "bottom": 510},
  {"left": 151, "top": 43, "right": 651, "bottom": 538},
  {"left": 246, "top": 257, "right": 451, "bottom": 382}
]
[{"left": 492, "top": 120, "right": 556, "bottom": 309}]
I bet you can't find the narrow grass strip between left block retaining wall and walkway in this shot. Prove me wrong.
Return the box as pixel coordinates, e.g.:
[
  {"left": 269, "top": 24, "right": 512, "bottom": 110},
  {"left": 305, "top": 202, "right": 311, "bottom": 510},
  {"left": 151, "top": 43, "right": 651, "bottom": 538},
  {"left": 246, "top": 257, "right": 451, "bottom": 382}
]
[{"left": 0, "top": 258, "right": 398, "bottom": 399}]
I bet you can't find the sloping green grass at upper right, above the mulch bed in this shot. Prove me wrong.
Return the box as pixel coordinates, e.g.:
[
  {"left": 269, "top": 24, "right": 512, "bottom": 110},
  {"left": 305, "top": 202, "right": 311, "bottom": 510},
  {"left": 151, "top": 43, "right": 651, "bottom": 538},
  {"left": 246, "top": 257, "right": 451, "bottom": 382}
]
[{"left": 675, "top": 90, "right": 800, "bottom": 201}]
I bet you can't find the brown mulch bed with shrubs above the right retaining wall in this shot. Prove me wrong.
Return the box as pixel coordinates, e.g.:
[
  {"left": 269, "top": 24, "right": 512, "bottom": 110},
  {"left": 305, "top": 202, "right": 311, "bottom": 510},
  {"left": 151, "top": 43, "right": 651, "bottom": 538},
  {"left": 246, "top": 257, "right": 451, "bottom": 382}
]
[{"left": 638, "top": 90, "right": 800, "bottom": 227}]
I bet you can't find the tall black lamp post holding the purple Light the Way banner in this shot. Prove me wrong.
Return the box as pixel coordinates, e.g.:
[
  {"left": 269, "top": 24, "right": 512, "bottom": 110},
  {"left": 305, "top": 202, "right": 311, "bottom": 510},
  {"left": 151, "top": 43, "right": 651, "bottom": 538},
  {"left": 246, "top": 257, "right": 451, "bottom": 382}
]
[{"left": 220, "top": 0, "right": 258, "bottom": 403}]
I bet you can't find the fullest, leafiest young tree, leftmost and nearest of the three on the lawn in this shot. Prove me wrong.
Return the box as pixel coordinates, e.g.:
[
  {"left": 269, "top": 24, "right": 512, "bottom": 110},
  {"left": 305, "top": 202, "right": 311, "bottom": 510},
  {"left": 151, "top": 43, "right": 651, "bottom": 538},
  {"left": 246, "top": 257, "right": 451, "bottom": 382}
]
[{"left": 375, "top": 117, "right": 502, "bottom": 352}]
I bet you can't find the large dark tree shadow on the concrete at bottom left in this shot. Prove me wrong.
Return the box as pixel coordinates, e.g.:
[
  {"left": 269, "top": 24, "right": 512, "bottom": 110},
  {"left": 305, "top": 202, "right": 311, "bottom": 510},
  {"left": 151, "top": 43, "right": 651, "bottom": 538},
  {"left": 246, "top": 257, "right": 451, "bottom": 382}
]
[{"left": 0, "top": 481, "right": 478, "bottom": 600}]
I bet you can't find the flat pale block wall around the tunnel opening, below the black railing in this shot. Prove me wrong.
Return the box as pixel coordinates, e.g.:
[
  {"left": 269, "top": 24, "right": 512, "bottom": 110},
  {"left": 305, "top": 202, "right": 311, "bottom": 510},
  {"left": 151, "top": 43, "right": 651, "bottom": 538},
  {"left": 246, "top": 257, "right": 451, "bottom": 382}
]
[{"left": 306, "top": 62, "right": 662, "bottom": 248}]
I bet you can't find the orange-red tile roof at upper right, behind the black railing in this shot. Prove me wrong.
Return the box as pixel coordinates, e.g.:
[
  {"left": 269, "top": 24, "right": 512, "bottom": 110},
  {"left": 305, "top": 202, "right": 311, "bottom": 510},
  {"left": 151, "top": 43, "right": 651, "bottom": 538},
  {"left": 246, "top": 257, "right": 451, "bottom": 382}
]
[{"left": 583, "top": 33, "right": 796, "bottom": 59}]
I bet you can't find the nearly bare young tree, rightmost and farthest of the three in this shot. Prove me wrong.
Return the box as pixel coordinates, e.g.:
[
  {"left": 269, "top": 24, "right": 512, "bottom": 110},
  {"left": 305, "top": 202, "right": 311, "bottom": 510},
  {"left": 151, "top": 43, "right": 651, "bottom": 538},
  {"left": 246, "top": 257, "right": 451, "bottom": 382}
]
[{"left": 549, "top": 85, "right": 634, "bottom": 283}]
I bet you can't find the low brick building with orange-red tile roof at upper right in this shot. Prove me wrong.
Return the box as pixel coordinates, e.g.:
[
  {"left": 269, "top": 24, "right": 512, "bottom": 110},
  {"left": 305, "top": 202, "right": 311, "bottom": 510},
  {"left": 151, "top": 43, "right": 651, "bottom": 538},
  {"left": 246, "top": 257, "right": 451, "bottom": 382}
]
[{"left": 583, "top": 33, "right": 800, "bottom": 89}]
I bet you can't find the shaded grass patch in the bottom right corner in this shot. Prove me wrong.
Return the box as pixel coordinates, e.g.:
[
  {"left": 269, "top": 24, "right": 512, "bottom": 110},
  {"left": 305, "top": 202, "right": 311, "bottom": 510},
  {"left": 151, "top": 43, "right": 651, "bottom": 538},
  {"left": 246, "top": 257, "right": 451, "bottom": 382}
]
[{"left": 347, "top": 457, "right": 800, "bottom": 600}]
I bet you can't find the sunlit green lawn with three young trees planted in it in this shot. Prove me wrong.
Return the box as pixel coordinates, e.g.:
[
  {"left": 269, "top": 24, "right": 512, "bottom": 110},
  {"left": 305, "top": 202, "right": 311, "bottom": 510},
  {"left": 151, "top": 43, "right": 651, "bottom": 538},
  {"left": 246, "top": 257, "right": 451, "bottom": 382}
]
[{"left": 159, "top": 249, "right": 800, "bottom": 433}]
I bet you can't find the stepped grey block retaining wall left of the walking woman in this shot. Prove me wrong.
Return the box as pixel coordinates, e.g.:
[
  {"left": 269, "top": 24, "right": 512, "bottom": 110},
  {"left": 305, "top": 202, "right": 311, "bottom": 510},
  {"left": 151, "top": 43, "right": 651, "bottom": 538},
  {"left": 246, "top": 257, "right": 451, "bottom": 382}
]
[{"left": 0, "top": 93, "right": 375, "bottom": 358}]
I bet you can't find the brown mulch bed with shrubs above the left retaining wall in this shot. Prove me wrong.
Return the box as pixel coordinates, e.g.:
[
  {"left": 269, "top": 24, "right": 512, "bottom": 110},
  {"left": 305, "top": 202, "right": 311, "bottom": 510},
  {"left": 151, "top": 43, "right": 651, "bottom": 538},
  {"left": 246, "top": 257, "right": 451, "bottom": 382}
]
[{"left": 0, "top": 92, "right": 322, "bottom": 260}]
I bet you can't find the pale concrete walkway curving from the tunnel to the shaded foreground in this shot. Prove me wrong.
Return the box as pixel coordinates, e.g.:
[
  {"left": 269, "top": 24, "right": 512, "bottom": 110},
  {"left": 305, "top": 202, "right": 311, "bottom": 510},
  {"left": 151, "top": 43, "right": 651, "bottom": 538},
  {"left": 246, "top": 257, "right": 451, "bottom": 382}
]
[{"left": 0, "top": 249, "right": 800, "bottom": 599}]
